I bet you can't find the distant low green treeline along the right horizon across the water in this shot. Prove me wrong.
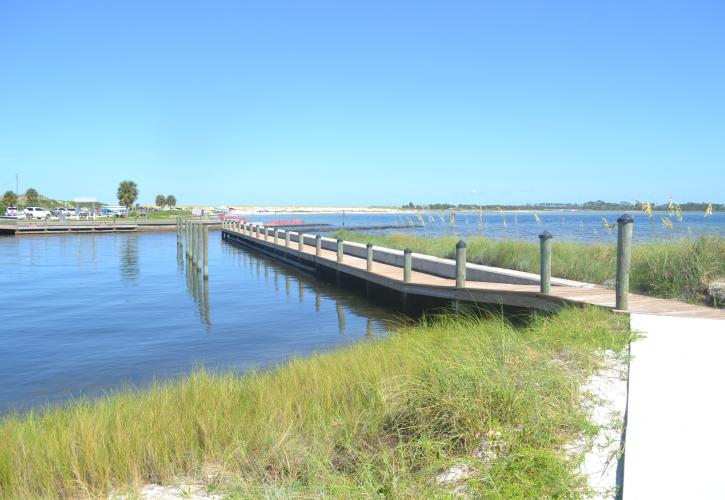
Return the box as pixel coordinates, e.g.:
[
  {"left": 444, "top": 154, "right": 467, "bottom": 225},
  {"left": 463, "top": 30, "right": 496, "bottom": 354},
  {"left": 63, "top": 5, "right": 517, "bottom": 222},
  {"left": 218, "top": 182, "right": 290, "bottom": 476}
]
[{"left": 401, "top": 200, "right": 725, "bottom": 212}]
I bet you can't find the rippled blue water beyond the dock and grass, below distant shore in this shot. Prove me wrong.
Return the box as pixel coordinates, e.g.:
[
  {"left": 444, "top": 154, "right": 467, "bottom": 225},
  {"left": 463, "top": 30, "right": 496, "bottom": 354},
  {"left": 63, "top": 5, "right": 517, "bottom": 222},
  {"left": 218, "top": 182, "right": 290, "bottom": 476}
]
[{"left": 248, "top": 211, "right": 725, "bottom": 243}]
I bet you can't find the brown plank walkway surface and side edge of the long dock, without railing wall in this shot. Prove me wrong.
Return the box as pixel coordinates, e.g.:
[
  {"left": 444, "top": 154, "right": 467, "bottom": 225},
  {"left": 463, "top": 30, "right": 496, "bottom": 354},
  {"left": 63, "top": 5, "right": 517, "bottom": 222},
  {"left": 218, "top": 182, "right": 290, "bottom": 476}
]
[{"left": 222, "top": 228, "right": 725, "bottom": 320}]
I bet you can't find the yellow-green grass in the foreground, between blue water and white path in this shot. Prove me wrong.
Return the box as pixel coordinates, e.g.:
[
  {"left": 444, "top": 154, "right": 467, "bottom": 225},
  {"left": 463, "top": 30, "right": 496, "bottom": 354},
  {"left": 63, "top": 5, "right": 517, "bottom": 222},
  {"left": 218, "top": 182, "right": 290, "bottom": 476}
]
[{"left": 0, "top": 309, "right": 630, "bottom": 498}]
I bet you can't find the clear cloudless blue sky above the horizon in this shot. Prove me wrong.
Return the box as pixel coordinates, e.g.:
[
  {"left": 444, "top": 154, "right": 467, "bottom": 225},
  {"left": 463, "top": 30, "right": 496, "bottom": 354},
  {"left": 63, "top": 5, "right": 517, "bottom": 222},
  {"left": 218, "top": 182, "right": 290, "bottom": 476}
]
[{"left": 0, "top": 0, "right": 725, "bottom": 205}]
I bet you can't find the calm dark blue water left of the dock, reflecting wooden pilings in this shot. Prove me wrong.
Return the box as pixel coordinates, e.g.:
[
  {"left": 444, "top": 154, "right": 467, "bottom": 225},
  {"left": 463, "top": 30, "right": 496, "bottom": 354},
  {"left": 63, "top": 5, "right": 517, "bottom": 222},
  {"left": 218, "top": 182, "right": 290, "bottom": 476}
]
[{"left": 0, "top": 232, "right": 393, "bottom": 412}]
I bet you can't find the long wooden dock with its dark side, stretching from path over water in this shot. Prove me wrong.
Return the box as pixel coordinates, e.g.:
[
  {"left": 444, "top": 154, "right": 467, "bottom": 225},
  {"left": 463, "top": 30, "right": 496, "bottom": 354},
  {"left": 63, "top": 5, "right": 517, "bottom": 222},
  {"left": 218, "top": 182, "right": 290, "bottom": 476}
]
[{"left": 222, "top": 223, "right": 725, "bottom": 320}]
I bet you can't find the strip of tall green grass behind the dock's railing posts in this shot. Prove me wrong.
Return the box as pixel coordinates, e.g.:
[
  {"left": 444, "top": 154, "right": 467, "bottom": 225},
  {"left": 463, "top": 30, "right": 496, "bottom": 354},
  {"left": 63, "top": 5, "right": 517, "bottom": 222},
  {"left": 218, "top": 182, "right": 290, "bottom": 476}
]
[{"left": 337, "top": 231, "right": 725, "bottom": 302}]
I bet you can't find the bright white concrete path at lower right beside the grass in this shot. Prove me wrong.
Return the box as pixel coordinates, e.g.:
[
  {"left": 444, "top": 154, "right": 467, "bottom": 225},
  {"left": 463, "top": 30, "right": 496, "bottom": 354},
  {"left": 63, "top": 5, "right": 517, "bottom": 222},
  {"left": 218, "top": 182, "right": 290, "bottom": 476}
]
[{"left": 623, "top": 314, "right": 725, "bottom": 500}]
